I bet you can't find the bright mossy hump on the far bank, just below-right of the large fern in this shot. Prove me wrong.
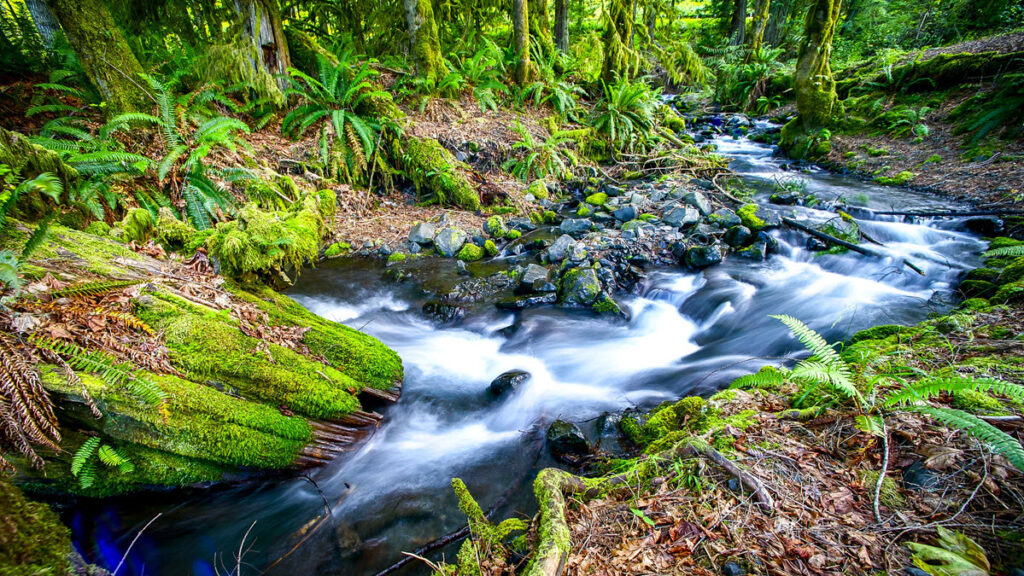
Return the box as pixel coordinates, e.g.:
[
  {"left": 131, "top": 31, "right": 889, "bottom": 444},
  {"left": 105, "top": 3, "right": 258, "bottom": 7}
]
[{"left": 401, "top": 136, "right": 480, "bottom": 210}]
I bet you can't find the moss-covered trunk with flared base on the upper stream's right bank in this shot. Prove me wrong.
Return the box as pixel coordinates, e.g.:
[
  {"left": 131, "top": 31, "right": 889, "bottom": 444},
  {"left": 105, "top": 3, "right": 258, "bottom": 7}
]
[{"left": 781, "top": 0, "right": 842, "bottom": 156}]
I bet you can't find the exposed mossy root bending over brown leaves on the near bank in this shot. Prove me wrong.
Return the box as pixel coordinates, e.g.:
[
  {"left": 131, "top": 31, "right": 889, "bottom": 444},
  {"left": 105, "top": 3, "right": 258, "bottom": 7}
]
[{"left": 526, "top": 439, "right": 775, "bottom": 576}]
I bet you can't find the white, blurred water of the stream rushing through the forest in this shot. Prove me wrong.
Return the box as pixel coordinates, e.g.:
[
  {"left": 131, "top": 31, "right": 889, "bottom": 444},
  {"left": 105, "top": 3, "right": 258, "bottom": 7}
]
[{"left": 70, "top": 127, "right": 984, "bottom": 576}]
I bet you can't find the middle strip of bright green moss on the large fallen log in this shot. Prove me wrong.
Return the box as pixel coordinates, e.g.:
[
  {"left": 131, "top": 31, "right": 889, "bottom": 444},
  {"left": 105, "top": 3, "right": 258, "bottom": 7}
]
[{"left": 137, "top": 293, "right": 362, "bottom": 418}]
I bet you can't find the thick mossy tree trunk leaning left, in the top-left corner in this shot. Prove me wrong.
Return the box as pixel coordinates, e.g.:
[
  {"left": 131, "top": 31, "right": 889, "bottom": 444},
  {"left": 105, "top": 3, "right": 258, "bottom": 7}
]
[{"left": 47, "top": 0, "right": 153, "bottom": 113}]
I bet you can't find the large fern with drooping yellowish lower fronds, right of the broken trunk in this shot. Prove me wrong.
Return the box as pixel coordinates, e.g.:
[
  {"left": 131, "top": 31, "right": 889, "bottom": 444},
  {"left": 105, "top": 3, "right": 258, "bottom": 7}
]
[{"left": 281, "top": 51, "right": 383, "bottom": 182}]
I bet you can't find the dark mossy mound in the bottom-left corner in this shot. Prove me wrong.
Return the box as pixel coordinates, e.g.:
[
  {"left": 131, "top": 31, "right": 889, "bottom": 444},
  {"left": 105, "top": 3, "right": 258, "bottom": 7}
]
[{"left": 0, "top": 475, "right": 72, "bottom": 576}]
